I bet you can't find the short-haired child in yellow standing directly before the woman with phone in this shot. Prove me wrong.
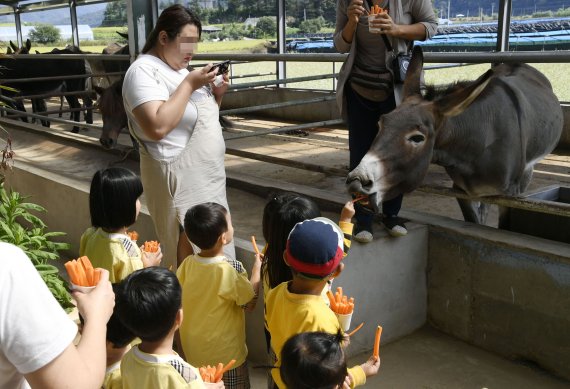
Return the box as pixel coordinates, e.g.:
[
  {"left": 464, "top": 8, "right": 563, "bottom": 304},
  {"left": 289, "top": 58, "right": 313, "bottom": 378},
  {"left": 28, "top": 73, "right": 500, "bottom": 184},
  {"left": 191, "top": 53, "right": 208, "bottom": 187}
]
[{"left": 176, "top": 203, "right": 261, "bottom": 389}]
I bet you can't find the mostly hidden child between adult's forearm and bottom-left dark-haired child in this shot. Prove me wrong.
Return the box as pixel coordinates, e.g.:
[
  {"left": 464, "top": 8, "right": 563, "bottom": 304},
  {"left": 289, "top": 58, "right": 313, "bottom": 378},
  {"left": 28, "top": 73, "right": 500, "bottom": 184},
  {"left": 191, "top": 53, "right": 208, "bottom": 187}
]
[{"left": 102, "top": 284, "right": 135, "bottom": 389}]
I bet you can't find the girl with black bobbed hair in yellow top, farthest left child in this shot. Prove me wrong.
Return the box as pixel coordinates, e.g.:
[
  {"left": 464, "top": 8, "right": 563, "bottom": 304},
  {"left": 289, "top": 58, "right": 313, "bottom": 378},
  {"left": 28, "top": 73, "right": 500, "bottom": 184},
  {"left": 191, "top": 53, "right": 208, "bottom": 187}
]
[{"left": 79, "top": 167, "right": 162, "bottom": 283}]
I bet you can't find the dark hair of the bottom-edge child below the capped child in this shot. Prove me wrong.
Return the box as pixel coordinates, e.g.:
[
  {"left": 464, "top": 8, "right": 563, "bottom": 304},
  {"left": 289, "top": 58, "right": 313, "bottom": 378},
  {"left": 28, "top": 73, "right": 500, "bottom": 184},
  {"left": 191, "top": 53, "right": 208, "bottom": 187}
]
[{"left": 279, "top": 331, "right": 348, "bottom": 389}]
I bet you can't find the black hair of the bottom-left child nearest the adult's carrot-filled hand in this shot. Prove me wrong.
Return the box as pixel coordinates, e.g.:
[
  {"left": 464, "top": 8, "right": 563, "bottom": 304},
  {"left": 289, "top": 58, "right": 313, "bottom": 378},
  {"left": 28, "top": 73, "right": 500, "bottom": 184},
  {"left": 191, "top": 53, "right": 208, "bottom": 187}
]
[{"left": 115, "top": 266, "right": 182, "bottom": 342}]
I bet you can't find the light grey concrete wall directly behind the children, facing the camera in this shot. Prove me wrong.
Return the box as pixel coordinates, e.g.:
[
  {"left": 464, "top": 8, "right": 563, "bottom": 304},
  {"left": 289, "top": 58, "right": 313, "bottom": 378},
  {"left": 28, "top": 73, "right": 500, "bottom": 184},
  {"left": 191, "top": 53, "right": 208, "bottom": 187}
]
[{"left": 7, "top": 163, "right": 428, "bottom": 364}]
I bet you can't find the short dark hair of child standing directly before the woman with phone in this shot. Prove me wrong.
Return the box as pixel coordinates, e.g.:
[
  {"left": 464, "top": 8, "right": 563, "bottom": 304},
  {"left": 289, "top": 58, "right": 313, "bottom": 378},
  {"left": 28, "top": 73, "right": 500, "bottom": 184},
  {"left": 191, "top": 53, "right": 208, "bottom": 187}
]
[{"left": 184, "top": 203, "right": 228, "bottom": 250}]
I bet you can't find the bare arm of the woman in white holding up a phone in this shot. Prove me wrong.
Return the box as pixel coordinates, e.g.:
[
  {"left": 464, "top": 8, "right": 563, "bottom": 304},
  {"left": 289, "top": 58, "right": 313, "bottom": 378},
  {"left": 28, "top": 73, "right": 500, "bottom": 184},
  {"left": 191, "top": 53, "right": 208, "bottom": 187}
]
[{"left": 133, "top": 64, "right": 216, "bottom": 141}]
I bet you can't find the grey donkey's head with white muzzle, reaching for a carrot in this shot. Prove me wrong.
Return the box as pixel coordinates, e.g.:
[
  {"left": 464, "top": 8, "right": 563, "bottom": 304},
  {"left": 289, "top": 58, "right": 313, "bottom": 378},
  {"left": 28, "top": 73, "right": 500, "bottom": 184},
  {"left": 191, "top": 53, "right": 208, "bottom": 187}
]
[{"left": 346, "top": 46, "right": 491, "bottom": 212}]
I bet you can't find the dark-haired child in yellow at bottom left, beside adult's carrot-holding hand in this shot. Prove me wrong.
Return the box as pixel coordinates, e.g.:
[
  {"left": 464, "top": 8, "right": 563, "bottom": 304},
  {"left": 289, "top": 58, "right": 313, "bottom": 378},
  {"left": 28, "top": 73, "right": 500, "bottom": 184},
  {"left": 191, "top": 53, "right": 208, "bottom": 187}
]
[{"left": 115, "top": 267, "right": 223, "bottom": 389}]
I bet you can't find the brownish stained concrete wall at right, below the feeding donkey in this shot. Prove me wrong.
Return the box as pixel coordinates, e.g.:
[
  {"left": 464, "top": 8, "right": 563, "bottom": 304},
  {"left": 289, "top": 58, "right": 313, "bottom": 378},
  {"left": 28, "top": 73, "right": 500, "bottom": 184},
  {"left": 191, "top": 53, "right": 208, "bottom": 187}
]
[{"left": 408, "top": 211, "right": 570, "bottom": 379}]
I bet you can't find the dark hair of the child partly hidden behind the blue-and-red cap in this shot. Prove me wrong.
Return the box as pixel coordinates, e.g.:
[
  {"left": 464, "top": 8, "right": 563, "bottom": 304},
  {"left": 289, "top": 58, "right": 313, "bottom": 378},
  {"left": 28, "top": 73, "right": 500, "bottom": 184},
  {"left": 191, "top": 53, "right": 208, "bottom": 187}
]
[{"left": 261, "top": 192, "right": 321, "bottom": 288}]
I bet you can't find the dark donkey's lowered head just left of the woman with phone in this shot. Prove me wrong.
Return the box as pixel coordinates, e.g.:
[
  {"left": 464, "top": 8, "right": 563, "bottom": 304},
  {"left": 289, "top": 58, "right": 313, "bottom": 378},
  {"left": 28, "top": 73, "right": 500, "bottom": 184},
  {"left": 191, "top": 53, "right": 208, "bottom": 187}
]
[{"left": 93, "top": 79, "right": 127, "bottom": 149}]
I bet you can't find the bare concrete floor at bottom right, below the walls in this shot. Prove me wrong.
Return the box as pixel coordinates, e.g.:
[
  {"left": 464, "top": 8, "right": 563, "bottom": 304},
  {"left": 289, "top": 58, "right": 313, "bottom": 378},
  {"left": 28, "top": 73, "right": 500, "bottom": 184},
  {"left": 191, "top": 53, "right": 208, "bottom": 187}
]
[{"left": 245, "top": 327, "right": 570, "bottom": 389}]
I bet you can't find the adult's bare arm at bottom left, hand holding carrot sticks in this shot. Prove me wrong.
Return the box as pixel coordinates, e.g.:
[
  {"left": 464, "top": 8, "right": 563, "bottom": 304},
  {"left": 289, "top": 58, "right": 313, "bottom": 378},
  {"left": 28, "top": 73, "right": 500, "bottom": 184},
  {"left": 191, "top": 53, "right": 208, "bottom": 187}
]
[{"left": 25, "top": 270, "right": 115, "bottom": 389}]
